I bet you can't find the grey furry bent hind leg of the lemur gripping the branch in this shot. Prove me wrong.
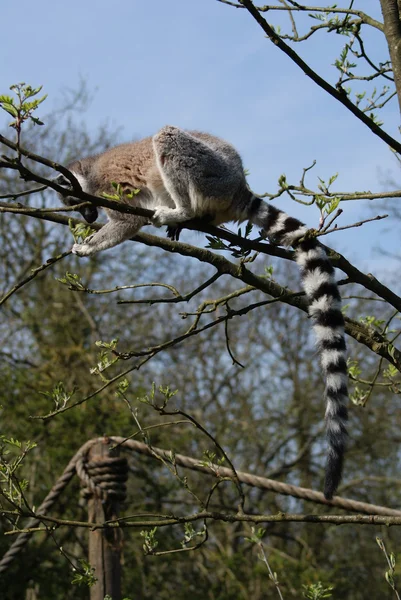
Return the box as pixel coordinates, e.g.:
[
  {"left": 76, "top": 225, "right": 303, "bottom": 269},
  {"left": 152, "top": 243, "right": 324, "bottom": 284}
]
[{"left": 152, "top": 126, "right": 236, "bottom": 229}]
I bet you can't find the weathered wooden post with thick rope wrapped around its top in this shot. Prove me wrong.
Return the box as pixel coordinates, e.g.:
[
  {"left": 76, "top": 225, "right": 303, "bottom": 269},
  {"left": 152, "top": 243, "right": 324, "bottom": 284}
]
[{"left": 86, "top": 438, "right": 127, "bottom": 600}]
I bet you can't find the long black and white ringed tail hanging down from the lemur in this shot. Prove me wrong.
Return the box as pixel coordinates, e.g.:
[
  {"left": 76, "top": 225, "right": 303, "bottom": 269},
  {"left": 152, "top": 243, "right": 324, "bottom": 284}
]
[{"left": 248, "top": 196, "right": 348, "bottom": 500}]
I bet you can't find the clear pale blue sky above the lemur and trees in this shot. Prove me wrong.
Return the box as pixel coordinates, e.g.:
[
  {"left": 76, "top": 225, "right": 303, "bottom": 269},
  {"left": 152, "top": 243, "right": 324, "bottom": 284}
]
[{"left": 0, "top": 0, "right": 399, "bottom": 272}]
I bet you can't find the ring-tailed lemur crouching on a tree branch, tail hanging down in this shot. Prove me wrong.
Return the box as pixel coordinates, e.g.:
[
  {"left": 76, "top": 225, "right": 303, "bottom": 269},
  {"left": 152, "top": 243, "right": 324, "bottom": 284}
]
[{"left": 56, "top": 126, "right": 348, "bottom": 499}]
